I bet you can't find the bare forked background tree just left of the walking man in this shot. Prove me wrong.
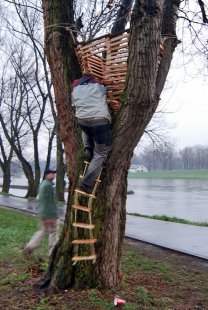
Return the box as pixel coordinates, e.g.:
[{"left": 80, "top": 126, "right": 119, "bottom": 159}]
[{"left": 1, "top": 1, "right": 57, "bottom": 196}]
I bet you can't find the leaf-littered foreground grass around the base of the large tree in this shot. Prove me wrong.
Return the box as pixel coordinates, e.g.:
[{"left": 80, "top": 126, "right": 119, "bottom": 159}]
[{"left": 0, "top": 209, "right": 208, "bottom": 310}]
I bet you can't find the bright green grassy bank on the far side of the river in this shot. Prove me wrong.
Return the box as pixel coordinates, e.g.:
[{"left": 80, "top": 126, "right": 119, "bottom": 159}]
[{"left": 128, "top": 169, "right": 208, "bottom": 180}]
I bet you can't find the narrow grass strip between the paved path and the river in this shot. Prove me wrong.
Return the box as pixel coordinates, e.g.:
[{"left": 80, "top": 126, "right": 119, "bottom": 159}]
[{"left": 127, "top": 213, "right": 208, "bottom": 227}]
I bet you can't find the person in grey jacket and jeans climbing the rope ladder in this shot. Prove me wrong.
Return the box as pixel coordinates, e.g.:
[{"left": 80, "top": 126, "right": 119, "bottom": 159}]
[{"left": 71, "top": 74, "right": 111, "bottom": 194}]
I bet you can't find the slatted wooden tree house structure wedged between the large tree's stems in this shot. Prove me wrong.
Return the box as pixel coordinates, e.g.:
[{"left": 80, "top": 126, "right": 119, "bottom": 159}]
[{"left": 76, "top": 31, "right": 129, "bottom": 113}]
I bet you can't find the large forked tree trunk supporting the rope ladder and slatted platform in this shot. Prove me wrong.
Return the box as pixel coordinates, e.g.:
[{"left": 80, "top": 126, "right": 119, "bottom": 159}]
[{"left": 39, "top": 0, "right": 177, "bottom": 289}]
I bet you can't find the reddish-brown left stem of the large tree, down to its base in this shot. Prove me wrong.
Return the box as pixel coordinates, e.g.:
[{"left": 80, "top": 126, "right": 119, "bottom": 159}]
[{"left": 37, "top": 0, "right": 81, "bottom": 289}]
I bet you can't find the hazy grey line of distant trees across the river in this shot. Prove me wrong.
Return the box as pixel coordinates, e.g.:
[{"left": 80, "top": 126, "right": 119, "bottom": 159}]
[{"left": 132, "top": 145, "right": 208, "bottom": 171}]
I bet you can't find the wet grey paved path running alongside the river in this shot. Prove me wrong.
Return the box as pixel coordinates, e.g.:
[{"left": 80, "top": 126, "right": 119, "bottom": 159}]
[{"left": 0, "top": 195, "right": 208, "bottom": 259}]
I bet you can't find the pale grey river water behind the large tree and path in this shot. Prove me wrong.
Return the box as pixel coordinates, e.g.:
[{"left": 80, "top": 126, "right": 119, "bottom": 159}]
[{"left": 0, "top": 179, "right": 208, "bottom": 222}]
